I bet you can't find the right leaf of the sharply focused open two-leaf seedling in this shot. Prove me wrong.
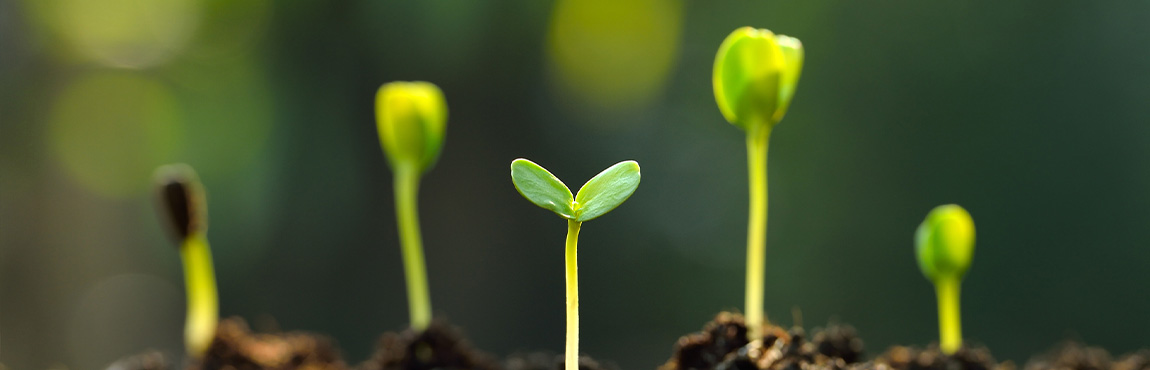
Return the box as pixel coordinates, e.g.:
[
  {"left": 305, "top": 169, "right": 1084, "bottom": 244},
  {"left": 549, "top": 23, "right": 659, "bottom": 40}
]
[{"left": 575, "top": 161, "right": 639, "bottom": 222}]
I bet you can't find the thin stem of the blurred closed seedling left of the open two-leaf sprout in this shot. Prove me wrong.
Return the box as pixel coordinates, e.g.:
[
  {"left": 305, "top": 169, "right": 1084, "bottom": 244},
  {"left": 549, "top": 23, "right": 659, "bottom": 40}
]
[{"left": 394, "top": 165, "right": 431, "bottom": 331}]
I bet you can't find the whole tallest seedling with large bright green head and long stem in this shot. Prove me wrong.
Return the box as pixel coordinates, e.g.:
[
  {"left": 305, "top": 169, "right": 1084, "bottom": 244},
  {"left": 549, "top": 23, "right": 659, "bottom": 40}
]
[{"left": 713, "top": 28, "right": 803, "bottom": 340}]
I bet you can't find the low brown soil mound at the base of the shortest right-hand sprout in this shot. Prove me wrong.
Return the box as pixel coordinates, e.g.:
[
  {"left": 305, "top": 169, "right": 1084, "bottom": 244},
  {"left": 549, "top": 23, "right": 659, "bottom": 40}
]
[{"left": 875, "top": 345, "right": 1014, "bottom": 370}]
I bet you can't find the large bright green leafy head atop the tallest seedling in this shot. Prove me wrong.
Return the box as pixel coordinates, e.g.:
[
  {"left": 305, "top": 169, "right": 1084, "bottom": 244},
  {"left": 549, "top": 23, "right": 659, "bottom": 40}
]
[{"left": 712, "top": 26, "right": 803, "bottom": 131}]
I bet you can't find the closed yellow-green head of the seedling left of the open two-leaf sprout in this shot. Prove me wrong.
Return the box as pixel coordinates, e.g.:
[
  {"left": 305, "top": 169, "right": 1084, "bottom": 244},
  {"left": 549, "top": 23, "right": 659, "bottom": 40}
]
[{"left": 375, "top": 82, "right": 447, "bottom": 172}]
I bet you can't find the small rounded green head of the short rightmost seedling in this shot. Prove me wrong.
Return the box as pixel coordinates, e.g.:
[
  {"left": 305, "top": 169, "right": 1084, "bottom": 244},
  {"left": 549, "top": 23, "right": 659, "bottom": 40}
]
[{"left": 914, "top": 205, "right": 974, "bottom": 282}]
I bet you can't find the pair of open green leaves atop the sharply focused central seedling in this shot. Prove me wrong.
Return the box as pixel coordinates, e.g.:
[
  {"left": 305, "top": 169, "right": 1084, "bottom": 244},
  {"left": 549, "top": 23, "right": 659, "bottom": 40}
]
[{"left": 511, "top": 159, "right": 641, "bottom": 222}]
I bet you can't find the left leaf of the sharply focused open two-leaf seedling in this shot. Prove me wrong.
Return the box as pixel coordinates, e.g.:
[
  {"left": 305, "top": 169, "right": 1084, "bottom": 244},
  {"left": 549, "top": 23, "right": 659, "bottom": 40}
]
[{"left": 511, "top": 159, "right": 575, "bottom": 219}]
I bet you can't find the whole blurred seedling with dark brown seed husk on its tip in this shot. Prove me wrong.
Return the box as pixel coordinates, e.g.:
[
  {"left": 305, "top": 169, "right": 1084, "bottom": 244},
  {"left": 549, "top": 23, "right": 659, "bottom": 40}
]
[{"left": 155, "top": 164, "right": 220, "bottom": 359}]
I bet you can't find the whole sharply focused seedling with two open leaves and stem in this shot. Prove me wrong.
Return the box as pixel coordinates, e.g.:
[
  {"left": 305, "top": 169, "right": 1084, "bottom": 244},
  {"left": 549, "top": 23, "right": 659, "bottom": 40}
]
[{"left": 511, "top": 159, "right": 639, "bottom": 370}]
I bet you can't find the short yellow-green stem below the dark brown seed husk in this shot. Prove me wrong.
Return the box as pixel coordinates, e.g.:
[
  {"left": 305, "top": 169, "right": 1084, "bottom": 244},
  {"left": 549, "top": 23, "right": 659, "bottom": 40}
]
[{"left": 179, "top": 232, "right": 220, "bottom": 359}]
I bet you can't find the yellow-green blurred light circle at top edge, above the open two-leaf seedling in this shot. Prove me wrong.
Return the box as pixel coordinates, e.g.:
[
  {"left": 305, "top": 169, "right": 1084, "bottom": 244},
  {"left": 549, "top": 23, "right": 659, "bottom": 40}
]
[{"left": 547, "top": 0, "right": 683, "bottom": 111}]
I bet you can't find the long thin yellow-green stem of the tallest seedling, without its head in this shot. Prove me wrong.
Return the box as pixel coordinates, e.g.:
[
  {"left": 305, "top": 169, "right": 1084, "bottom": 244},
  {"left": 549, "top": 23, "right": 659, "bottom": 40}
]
[{"left": 744, "top": 128, "right": 771, "bottom": 340}]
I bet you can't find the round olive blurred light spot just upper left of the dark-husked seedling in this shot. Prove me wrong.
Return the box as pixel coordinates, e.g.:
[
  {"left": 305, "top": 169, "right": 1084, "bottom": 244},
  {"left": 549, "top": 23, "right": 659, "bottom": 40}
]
[{"left": 48, "top": 72, "right": 183, "bottom": 196}]
